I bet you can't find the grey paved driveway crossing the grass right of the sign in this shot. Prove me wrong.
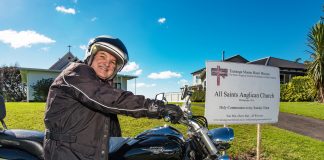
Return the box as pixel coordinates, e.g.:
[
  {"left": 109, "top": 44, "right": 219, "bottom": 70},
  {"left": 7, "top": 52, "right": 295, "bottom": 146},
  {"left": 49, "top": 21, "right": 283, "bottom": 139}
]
[{"left": 274, "top": 112, "right": 324, "bottom": 141}]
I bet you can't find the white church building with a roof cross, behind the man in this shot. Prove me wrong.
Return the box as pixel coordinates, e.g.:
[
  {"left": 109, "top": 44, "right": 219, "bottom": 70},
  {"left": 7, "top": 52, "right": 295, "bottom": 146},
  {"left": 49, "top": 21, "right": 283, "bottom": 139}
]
[{"left": 19, "top": 52, "right": 137, "bottom": 102}]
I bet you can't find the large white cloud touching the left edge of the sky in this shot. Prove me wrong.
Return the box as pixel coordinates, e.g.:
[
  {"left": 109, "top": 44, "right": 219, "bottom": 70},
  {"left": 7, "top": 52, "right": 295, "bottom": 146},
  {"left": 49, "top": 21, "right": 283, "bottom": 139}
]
[{"left": 0, "top": 29, "right": 55, "bottom": 48}]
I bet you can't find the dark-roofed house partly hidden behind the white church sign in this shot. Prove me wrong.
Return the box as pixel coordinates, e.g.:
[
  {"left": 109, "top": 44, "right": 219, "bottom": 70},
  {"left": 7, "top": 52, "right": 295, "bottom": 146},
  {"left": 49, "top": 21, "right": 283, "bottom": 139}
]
[{"left": 189, "top": 55, "right": 307, "bottom": 90}]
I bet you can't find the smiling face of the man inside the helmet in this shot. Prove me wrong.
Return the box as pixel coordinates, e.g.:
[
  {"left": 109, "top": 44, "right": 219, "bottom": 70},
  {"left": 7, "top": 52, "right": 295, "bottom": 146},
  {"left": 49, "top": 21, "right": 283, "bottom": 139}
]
[{"left": 91, "top": 51, "right": 117, "bottom": 79}]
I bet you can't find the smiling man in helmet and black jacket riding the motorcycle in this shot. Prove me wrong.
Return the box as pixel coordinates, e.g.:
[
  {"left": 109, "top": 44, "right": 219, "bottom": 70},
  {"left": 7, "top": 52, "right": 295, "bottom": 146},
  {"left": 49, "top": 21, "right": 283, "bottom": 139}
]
[{"left": 44, "top": 36, "right": 182, "bottom": 160}]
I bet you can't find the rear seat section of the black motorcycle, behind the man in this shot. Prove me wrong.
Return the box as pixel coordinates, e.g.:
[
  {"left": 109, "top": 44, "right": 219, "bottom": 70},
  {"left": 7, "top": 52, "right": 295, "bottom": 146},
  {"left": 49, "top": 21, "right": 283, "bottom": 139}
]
[{"left": 0, "top": 129, "right": 44, "bottom": 159}]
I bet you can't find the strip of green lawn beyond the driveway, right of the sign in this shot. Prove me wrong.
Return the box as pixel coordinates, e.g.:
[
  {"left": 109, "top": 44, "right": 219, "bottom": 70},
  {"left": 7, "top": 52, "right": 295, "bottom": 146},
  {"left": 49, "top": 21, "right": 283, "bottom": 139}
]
[{"left": 280, "top": 102, "right": 324, "bottom": 120}]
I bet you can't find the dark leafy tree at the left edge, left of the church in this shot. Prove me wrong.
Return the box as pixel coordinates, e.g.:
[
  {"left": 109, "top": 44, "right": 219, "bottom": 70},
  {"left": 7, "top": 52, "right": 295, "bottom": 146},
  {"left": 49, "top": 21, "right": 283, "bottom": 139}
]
[{"left": 0, "top": 64, "right": 27, "bottom": 101}]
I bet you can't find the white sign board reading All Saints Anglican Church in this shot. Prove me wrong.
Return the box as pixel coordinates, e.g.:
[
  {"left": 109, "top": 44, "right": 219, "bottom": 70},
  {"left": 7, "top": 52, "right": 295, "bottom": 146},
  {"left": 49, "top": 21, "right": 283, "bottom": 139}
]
[{"left": 205, "top": 61, "right": 280, "bottom": 124}]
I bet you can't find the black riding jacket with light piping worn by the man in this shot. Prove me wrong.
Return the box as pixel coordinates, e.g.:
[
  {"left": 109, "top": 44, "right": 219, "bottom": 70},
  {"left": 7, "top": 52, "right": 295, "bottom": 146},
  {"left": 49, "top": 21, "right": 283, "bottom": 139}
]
[{"left": 44, "top": 63, "right": 154, "bottom": 160}]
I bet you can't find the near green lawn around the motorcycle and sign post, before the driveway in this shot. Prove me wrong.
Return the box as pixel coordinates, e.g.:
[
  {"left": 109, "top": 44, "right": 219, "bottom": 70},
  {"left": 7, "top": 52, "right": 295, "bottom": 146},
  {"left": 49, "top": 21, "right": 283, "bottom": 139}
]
[{"left": 1, "top": 102, "right": 324, "bottom": 160}]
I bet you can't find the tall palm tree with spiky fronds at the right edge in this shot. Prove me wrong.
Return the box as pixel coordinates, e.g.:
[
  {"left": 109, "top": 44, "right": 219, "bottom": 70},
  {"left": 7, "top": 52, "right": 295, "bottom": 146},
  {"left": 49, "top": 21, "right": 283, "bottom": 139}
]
[{"left": 307, "top": 21, "right": 324, "bottom": 103}]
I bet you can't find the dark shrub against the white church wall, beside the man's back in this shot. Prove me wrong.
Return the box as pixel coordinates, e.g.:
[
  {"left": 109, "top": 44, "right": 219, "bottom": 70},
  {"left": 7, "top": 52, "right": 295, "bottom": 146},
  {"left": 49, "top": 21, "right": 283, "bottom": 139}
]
[{"left": 32, "top": 78, "right": 54, "bottom": 102}]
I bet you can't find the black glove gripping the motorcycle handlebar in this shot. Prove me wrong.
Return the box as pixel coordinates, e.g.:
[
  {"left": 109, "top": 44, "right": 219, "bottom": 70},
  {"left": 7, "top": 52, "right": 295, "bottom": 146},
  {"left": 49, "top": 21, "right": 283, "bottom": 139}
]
[{"left": 160, "top": 104, "right": 183, "bottom": 124}]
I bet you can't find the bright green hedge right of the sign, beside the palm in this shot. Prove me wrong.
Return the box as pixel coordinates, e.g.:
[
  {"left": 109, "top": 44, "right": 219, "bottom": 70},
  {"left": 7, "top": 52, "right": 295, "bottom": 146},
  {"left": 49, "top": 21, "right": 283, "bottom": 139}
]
[{"left": 280, "top": 76, "right": 316, "bottom": 102}]
